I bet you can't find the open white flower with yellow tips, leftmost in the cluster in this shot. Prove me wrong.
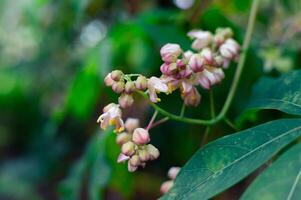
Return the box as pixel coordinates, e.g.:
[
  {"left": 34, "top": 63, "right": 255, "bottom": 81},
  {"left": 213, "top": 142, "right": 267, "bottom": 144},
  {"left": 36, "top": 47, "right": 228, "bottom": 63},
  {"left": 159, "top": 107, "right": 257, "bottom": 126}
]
[{"left": 97, "top": 103, "right": 124, "bottom": 132}]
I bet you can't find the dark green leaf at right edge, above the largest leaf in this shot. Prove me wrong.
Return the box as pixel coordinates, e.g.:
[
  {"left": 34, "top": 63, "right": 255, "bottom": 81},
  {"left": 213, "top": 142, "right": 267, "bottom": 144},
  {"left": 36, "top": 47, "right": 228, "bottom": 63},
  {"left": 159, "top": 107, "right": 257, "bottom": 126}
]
[{"left": 248, "top": 70, "right": 301, "bottom": 115}]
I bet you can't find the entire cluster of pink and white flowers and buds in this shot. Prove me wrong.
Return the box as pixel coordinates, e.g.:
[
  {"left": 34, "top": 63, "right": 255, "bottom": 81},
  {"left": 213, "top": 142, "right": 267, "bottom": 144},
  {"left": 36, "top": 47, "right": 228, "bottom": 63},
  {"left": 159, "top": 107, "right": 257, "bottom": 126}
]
[{"left": 97, "top": 28, "right": 240, "bottom": 172}]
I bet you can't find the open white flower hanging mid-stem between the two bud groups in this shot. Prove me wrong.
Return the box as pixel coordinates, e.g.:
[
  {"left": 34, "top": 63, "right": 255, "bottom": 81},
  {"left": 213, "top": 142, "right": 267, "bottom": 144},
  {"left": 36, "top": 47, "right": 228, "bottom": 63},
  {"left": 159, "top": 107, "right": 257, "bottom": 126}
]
[{"left": 148, "top": 76, "right": 168, "bottom": 103}]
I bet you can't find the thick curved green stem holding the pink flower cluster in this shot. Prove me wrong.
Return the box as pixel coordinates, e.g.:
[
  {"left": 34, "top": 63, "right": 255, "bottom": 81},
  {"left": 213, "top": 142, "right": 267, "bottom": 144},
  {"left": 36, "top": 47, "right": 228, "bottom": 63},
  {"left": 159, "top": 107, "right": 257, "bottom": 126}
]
[{"left": 139, "top": 0, "right": 259, "bottom": 125}]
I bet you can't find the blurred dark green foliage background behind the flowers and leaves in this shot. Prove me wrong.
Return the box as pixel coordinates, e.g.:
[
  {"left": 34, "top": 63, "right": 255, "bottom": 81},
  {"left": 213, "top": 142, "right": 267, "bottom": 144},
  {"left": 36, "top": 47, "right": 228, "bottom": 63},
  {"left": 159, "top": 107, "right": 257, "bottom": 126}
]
[{"left": 0, "top": 0, "right": 301, "bottom": 200}]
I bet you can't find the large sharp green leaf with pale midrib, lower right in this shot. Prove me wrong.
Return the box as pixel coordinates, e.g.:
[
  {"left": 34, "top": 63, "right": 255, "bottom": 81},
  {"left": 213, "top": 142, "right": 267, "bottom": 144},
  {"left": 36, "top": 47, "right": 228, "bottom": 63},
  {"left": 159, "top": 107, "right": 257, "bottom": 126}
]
[{"left": 162, "top": 119, "right": 301, "bottom": 200}]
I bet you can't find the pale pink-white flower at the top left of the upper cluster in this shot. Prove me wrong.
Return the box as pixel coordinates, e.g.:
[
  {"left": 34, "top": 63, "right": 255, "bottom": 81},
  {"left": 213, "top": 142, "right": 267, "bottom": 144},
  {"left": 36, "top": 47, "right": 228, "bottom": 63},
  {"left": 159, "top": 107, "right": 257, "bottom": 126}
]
[{"left": 188, "top": 30, "right": 213, "bottom": 51}]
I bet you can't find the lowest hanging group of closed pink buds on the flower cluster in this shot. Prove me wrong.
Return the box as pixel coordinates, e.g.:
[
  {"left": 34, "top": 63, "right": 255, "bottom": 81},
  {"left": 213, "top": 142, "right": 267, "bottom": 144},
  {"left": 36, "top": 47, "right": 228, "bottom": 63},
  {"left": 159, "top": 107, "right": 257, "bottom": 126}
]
[{"left": 116, "top": 118, "right": 160, "bottom": 172}]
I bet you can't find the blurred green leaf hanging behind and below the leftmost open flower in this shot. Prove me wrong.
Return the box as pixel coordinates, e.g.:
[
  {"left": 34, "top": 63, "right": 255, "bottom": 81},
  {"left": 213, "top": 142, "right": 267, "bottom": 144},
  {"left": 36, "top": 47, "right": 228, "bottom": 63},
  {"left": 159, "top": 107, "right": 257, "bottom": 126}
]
[{"left": 60, "top": 130, "right": 112, "bottom": 200}]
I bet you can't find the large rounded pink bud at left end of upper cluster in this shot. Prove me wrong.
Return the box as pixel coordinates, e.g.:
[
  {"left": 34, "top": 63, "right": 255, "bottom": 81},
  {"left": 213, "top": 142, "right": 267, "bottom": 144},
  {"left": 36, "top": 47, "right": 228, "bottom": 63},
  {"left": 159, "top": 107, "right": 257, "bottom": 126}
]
[{"left": 160, "top": 43, "right": 182, "bottom": 63}]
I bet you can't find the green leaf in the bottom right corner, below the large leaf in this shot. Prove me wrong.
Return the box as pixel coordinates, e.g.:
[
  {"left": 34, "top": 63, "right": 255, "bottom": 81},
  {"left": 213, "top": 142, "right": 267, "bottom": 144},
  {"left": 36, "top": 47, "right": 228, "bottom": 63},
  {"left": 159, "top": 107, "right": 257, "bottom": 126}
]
[{"left": 242, "top": 143, "right": 301, "bottom": 200}]
